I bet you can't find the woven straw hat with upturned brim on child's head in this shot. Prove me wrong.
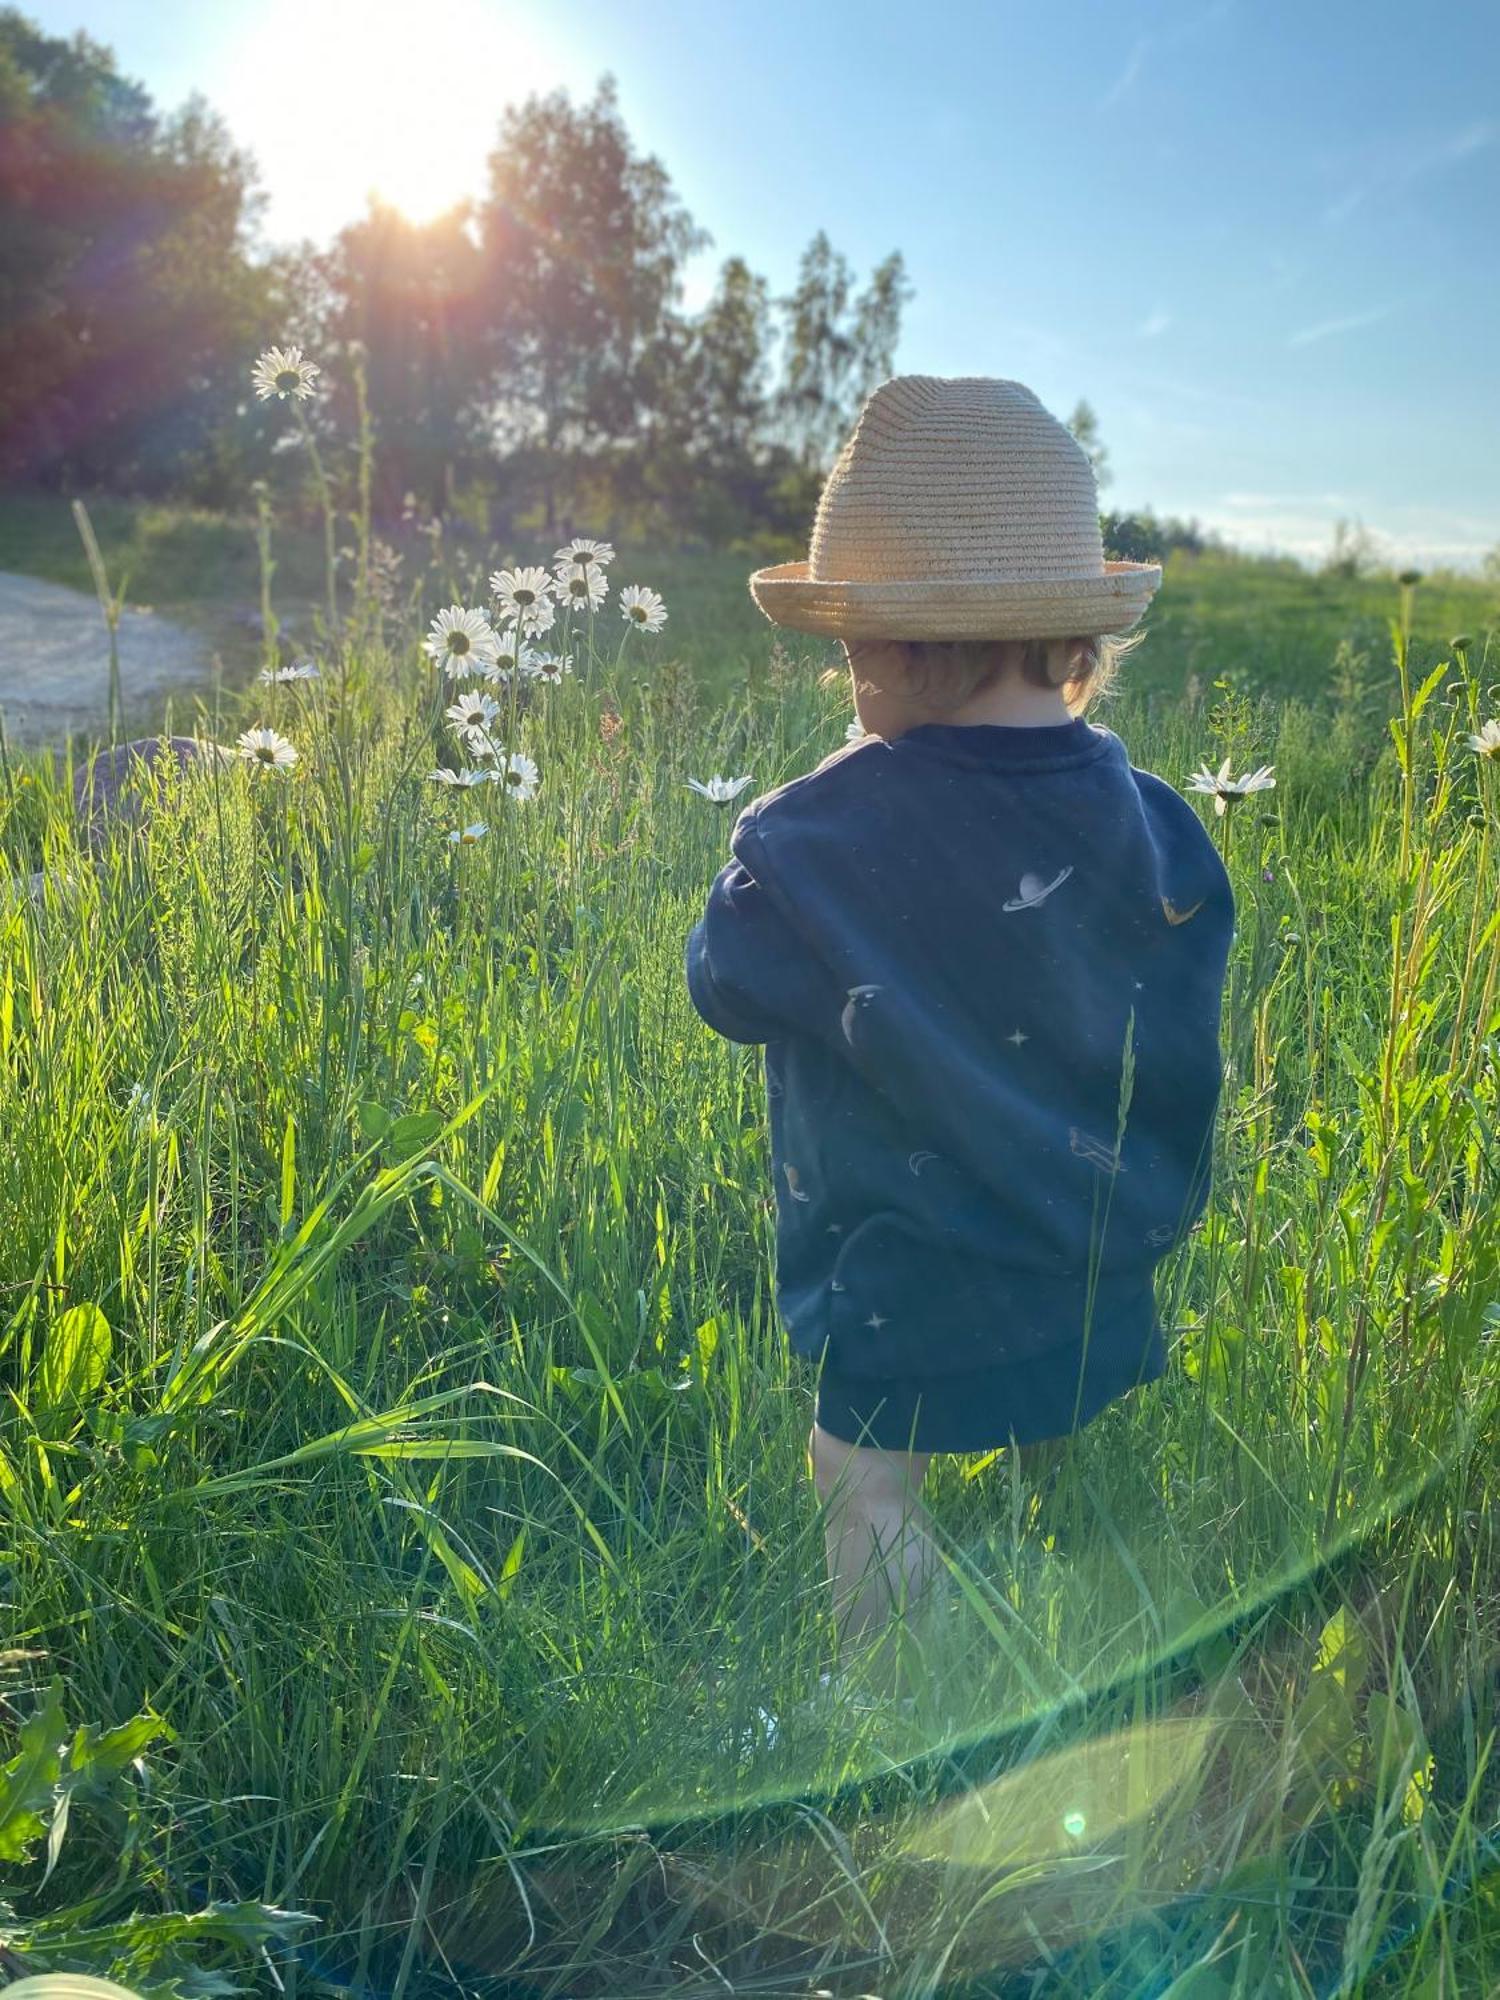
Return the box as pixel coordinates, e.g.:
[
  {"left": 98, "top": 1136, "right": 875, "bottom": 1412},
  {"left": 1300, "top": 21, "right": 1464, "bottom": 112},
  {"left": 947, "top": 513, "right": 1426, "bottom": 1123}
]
[{"left": 750, "top": 376, "right": 1162, "bottom": 638}]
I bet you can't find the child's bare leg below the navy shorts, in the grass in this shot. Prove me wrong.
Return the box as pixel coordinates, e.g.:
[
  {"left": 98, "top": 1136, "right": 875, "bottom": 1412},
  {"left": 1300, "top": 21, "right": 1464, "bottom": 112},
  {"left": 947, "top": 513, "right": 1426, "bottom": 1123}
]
[{"left": 808, "top": 1424, "right": 940, "bottom": 1680}]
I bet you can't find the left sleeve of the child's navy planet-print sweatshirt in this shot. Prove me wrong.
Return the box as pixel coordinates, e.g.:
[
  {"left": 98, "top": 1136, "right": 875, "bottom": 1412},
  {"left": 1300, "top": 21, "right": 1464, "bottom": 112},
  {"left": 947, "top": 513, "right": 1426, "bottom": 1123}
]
[{"left": 686, "top": 808, "right": 838, "bottom": 1042}]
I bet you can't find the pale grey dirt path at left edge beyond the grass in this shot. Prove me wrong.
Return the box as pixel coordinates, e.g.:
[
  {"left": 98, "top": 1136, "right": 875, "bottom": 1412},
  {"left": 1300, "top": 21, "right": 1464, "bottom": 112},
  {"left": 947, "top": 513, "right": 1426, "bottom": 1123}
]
[{"left": 0, "top": 570, "right": 210, "bottom": 744}]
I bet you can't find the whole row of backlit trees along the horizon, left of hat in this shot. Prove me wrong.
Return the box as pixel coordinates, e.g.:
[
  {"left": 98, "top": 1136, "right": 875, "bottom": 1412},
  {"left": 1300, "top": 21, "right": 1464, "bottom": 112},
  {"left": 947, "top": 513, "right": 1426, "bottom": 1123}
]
[{"left": 0, "top": 8, "right": 912, "bottom": 544}]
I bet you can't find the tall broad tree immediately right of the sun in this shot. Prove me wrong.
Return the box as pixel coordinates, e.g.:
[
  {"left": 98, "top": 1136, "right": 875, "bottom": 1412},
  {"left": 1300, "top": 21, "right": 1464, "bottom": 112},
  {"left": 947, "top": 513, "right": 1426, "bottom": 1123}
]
[{"left": 478, "top": 76, "right": 710, "bottom": 534}]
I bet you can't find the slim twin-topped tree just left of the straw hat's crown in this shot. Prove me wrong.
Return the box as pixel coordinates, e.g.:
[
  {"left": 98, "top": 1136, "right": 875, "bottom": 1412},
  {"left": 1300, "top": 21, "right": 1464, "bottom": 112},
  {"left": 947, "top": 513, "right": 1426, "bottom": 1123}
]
[{"left": 776, "top": 230, "right": 912, "bottom": 470}]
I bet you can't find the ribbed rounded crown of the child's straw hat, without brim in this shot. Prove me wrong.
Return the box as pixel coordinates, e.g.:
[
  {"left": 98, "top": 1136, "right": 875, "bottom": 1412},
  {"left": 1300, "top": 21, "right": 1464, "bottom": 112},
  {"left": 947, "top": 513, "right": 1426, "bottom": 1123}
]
[{"left": 808, "top": 376, "right": 1104, "bottom": 584}]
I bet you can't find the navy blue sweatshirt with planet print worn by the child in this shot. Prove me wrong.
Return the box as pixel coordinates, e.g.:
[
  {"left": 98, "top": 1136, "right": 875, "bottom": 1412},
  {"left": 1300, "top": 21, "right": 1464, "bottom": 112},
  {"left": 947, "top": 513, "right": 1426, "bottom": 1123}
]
[{"left": 686, "top": 716, "right": 1234, "bottom": 1378}]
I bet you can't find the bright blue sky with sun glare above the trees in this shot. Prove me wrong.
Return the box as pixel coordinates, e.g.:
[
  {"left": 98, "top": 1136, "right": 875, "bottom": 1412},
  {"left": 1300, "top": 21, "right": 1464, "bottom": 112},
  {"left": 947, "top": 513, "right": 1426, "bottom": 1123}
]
[{"left": 22, "top": 0, "right": 1500, "bottom": 568}]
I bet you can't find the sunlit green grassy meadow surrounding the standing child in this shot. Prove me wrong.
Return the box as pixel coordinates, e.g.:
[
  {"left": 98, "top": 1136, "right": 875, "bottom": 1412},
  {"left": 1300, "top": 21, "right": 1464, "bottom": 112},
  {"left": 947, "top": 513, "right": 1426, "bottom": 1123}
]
[{"left": 0, "top": 488, "right": 1500, "bottom": 2000}]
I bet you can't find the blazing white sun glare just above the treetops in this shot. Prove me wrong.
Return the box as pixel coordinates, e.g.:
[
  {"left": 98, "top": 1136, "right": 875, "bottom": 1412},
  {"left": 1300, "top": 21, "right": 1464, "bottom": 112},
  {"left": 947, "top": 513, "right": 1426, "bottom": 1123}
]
[{"left": 222, "top": 0, "right": 570, "bottom": 240}]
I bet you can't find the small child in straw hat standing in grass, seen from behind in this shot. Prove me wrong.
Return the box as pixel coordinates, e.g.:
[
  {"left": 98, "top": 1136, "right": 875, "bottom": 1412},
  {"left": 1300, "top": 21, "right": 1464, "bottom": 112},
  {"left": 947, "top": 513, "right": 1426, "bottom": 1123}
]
[{"left": 686, "top": 376, "right": 1234, "bottom": 1688}]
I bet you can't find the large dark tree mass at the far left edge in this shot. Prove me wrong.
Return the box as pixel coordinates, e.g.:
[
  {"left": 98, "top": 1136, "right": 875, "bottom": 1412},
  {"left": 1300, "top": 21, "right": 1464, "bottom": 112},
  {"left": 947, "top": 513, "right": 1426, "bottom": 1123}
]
[{"left": 0, "top": 8, "right": 272, "bottom": 498}]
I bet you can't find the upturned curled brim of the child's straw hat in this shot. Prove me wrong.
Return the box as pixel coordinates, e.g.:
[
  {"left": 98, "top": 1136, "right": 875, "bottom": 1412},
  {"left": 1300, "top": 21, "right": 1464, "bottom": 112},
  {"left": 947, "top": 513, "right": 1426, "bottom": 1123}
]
[{"left": 750, "top": 562, "right": 1162, "bottom": 640}]
